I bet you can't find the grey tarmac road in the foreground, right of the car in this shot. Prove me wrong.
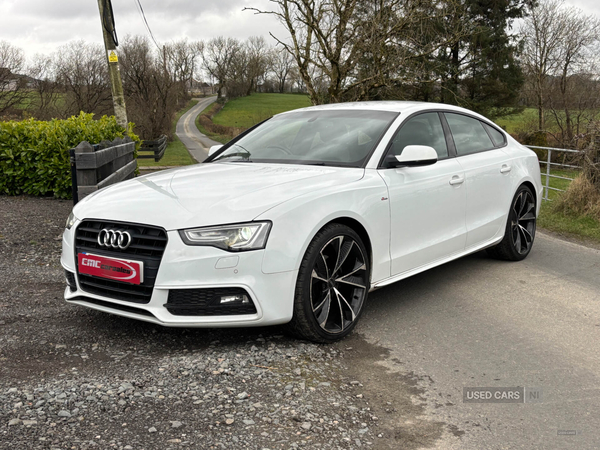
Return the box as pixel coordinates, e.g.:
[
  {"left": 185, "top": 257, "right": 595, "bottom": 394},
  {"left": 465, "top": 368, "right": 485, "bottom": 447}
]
[{"left": 356, "top": 233, "right": 600, "bottom": 449}]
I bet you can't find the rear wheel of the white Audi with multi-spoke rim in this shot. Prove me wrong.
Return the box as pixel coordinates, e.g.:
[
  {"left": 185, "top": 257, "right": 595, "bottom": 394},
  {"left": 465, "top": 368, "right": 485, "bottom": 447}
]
[{"left": 488, "top": 185, "right": 536, "bottom": 261}]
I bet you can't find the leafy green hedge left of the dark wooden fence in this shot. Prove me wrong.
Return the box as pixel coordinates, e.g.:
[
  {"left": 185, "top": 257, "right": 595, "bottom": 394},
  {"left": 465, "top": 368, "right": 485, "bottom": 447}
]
[{"left": 0, "top": 112, "right": 138, "bottom": 198}]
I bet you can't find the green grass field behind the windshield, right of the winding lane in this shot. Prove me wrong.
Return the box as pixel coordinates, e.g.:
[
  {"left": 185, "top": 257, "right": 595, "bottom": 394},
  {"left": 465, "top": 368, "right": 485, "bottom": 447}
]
[{"left": 213, "top": 94, "right": 311, "bottom": 128}]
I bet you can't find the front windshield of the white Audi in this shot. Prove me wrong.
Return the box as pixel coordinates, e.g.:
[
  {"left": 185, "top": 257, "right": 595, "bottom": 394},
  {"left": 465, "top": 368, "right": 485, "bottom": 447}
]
[{"left": 214, "top": 110, "right": 398, "bottom": 167}]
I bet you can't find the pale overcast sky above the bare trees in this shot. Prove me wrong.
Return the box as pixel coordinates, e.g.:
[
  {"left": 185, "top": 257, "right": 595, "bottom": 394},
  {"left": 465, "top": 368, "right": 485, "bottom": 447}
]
[{"left": 0, "top": 0, "right": 600, "bottom": 61}]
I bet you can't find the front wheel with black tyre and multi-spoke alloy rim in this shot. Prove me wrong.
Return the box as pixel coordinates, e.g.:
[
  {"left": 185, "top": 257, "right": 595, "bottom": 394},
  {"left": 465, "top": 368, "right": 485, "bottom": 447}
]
[{"left": 286, "top": 223, "right": 371, "bottom": 343}]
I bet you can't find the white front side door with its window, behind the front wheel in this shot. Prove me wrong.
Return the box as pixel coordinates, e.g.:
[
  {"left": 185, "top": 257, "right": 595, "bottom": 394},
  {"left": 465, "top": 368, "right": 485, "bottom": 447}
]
[{"left": 379, "top": 112, "right": 466, "bottom": 276}]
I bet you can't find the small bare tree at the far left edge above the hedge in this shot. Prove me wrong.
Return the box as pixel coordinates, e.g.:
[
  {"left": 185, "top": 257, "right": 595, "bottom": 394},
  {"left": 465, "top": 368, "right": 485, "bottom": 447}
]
[{"left": 0, "top": 41, "right": 25, "bottom": 116}]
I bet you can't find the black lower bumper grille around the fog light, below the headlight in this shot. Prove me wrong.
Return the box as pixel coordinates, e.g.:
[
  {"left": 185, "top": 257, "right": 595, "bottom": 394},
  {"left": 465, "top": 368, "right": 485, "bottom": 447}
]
[{"left": 164, "top": 288, "right": 256, "bottom": 316}]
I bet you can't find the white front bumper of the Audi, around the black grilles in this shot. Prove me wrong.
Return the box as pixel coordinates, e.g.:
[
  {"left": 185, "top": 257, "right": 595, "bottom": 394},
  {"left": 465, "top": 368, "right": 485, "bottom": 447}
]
[{"left": 61, "top": 224, "right": 298, "bottom": 327}]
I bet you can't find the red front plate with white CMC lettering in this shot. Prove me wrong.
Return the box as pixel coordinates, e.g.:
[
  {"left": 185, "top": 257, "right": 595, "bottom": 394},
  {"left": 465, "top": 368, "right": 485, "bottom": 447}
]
[{"left": 77, "top": 253, "right": 144, "bottom": 284}]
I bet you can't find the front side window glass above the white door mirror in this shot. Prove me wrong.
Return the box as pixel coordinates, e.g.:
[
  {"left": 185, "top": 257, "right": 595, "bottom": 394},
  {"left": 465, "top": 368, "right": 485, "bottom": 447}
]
[{"left": 390, "top": 112, "right": 448, "bottom": 159}]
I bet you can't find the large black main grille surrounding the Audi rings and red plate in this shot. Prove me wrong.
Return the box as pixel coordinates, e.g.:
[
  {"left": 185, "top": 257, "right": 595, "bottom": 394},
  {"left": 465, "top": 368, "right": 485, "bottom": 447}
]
[{"left": 75, "top": 220, "right": 167, "bottom": 303}]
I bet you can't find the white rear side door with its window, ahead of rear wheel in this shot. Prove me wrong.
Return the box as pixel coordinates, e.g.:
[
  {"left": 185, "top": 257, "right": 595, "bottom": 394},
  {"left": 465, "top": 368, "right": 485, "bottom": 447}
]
[{"left": 444, "top": 112, "right": 512, "bottom": 248}]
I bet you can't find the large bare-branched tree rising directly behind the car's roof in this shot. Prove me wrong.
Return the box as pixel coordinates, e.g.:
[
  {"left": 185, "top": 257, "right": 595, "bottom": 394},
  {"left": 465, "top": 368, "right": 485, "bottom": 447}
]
[{"left": 246, "top": 0, "right": 474, "bottom": 104}]
